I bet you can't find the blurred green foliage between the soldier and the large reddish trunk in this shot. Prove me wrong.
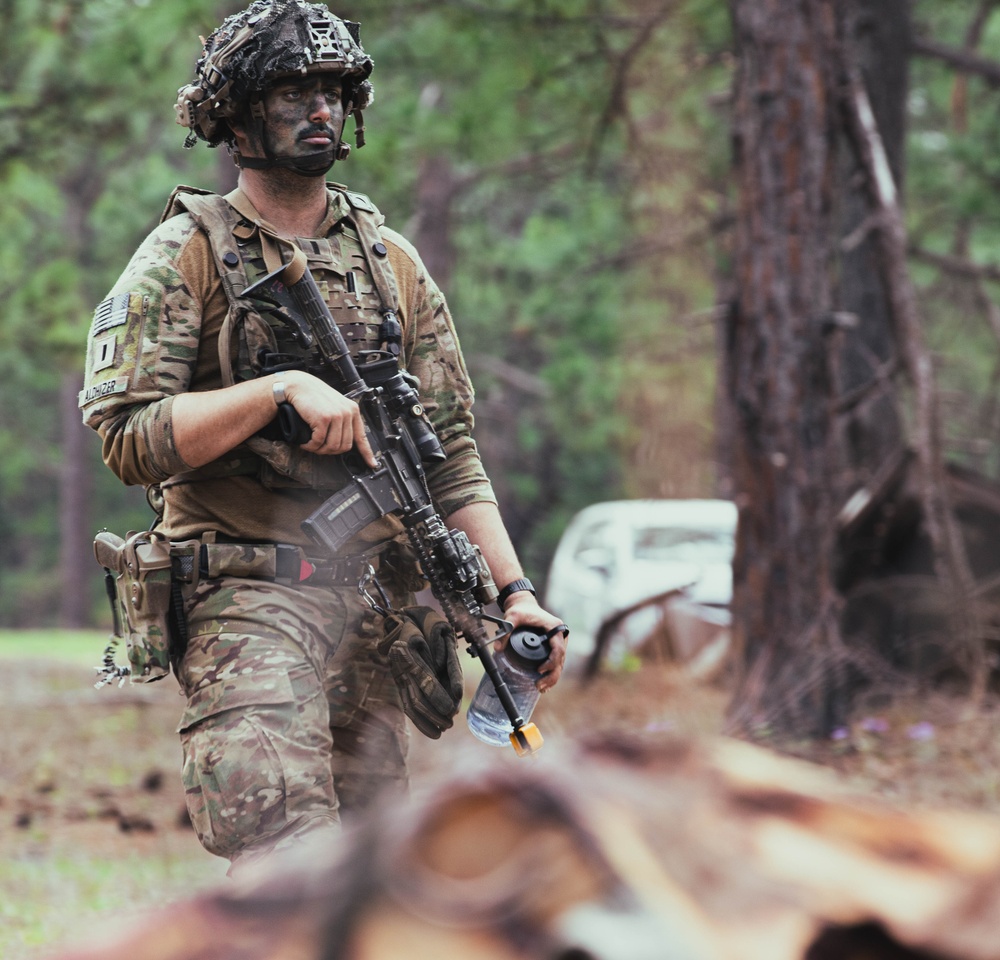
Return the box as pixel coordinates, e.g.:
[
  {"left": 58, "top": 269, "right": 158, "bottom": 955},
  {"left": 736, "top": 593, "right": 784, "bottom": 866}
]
[{"left": 339, "top": 0, "right": 728, "bottom": 579}]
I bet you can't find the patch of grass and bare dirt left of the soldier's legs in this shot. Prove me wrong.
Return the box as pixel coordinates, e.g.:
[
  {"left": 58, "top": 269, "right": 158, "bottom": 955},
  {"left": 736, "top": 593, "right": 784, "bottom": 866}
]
[{"left": 0, "top": 629, "right": 227, "bottom": 960}]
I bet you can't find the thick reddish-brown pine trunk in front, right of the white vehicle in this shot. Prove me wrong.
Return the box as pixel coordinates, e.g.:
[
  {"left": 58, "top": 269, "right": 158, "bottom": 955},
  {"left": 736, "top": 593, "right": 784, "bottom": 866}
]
[{"left": 726, "top": 0, "right": 840, "bottom": 734}]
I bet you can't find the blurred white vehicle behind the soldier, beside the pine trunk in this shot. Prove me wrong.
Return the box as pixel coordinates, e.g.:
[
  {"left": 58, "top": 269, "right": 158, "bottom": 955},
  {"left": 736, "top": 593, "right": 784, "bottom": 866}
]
[{"left": 545, "top": 500, "right": 736, "bottom": 662}]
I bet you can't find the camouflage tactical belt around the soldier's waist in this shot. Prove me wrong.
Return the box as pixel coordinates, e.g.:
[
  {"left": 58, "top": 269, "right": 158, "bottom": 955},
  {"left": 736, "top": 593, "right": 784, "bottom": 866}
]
[{"left": 170, "top": 540, "right": 384, "bottom": 587}]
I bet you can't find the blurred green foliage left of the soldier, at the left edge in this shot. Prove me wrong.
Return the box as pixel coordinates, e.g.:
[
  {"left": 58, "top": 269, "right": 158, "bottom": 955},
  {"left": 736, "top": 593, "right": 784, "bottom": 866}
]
[{"left": 0, "top": 0, "right": 213, "bottom": 623}]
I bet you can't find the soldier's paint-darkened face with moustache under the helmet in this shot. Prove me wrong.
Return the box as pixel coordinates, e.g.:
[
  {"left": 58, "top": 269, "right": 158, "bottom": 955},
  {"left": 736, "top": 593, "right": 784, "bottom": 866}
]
[{"left": 247, "top": 74, "right": 344, "bottom": 157}]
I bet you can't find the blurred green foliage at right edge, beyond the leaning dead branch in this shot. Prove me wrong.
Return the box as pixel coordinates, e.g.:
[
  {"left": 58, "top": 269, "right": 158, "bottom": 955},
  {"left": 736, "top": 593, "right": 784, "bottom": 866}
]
[{"left": 905, "top": 2, "right": 1000, "bottom": 477}]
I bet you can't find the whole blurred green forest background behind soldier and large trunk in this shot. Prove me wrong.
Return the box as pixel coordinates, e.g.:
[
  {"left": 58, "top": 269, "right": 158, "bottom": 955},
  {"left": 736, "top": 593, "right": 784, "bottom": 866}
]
[{"left": 0, "top": 0, "right": 1000, "bottom": 627}]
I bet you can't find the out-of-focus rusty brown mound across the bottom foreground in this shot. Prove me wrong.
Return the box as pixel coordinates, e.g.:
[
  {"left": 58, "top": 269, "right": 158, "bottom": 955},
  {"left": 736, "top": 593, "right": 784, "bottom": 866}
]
[{"left": 48, "top": 740, "right": 1000, "bottom": 960}]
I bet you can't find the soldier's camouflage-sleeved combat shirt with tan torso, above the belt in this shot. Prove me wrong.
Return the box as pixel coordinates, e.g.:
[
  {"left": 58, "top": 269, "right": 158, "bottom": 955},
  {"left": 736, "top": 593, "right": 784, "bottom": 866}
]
[{"left": 80, "top": 184, "right": 495, "bottom": 544}]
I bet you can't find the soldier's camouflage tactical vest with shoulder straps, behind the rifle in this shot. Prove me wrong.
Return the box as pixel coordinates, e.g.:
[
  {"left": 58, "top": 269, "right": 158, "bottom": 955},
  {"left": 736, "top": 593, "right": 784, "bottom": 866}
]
[{"left": 161, "top": 184, "right": 399, "bottom": 490}]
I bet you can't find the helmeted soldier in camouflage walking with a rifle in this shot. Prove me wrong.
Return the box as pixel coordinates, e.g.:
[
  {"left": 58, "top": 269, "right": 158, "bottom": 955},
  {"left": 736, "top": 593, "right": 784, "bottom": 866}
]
[{"left": 81, "top": 0, "right": 565, "bottom": 870}]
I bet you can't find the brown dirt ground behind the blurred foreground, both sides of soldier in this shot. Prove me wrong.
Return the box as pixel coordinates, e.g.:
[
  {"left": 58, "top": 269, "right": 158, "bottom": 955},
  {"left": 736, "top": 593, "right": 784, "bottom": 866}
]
[{"left": 0, "top": 648, "right": 1000, "bottom": 960}]
